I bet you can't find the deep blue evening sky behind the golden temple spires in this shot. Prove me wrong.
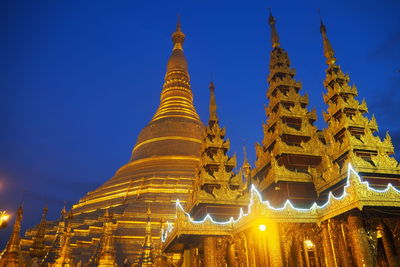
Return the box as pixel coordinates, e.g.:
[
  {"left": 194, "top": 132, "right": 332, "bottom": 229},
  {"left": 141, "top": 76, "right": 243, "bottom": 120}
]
[{"left": 0, "top": 0, "right": 400, "bottom": 248}]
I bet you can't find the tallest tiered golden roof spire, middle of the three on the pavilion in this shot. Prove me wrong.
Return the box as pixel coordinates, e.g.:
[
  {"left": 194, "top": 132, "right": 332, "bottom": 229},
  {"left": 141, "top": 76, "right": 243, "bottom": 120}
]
[{"left": 252, "top": 13, "right": 323, "bottom": 208}]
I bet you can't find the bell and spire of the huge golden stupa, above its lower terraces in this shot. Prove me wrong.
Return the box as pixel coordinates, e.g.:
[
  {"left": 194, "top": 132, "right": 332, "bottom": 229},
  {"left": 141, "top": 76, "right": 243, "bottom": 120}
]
[{"left": 73, "top": 18, "right": 203, "bottom": 214}]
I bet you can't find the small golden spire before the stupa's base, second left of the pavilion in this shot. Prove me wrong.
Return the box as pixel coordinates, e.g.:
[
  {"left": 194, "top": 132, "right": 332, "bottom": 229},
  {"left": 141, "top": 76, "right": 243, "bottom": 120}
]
[{"left": 97, "top": 209, "right": 117, "bottom": 267}]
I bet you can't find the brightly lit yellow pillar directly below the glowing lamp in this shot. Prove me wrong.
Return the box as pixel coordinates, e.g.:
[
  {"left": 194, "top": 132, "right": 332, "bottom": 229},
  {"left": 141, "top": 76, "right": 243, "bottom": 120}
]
[{"left": 266, "top": 222, "right": 283, "bottom": 267}]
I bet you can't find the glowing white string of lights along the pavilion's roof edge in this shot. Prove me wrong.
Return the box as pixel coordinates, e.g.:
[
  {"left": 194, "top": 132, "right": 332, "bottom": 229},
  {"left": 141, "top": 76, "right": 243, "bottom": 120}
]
[{"left": 161, "top": 163, "right": 400, "bottom": 242}]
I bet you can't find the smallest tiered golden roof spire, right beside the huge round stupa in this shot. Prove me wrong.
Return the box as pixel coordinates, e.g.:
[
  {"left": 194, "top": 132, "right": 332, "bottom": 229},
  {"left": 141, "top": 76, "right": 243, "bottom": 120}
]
[{"left": 188, "top": 82, "right": 247, "bottom": 222}]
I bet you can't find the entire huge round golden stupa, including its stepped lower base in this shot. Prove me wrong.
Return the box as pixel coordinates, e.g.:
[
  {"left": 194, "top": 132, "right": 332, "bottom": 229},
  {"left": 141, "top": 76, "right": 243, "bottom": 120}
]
[{"left": 16, "top": 18, "right": 204, "bottom": 264}]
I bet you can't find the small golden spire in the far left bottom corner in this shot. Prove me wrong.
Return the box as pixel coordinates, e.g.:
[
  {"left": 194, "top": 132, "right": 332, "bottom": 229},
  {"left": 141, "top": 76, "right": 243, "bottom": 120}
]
[{"left": 0, "top": 205, "right": 23, "bottom": 267}]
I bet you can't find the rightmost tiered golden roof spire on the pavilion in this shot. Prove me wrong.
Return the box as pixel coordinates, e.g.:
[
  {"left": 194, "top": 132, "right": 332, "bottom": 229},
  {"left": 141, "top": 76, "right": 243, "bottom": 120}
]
[{"left": 315, "top": 20, "right": 400, "bottom": 193}]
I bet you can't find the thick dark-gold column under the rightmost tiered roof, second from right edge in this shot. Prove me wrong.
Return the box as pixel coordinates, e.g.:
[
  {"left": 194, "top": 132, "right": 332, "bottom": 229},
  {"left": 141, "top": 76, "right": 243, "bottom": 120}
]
[{"left": 347, "top": 213, "right": 374, "bottom": 267}]
